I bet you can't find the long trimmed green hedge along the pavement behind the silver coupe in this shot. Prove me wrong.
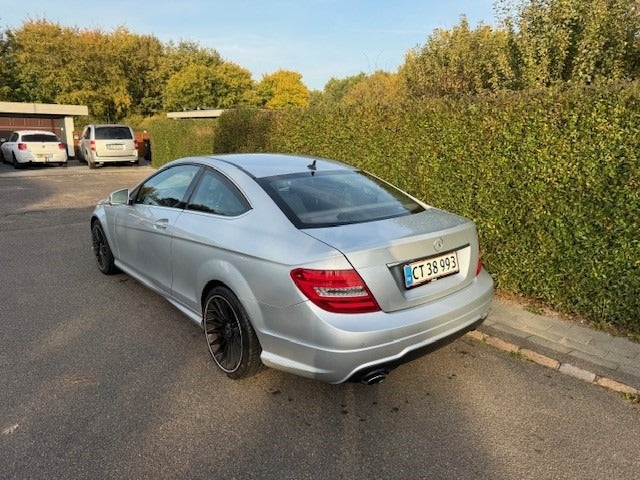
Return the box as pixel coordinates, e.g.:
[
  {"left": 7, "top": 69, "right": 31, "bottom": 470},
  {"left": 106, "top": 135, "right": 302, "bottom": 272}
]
[{"left": 142, "top": 84, "right": 640, "bottom": 332}]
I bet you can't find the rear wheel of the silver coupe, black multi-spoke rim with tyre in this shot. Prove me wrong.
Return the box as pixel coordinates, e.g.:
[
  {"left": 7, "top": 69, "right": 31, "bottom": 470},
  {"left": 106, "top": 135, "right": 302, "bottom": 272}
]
[{"left": 202, "top": 286, "right": 262, "bottom": 379}]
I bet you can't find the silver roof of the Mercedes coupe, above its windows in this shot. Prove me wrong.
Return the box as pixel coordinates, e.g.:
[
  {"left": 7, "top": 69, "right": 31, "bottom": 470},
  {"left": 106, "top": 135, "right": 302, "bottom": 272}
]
[{"left": 201, "top": 153, "right": 356, "bottom": 178}]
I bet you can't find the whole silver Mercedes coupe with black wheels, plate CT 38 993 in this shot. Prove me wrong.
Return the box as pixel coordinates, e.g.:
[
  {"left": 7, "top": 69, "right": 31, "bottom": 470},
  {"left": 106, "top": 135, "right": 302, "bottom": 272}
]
[{"left": 91, "top": 154, "right": 493, "bottom": 384}]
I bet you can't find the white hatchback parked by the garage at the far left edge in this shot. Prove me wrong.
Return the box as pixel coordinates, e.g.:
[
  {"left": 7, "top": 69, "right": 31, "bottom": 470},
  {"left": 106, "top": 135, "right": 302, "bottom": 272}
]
[{"left": 0, "top": 130, "right": 67, "bottom": 168}]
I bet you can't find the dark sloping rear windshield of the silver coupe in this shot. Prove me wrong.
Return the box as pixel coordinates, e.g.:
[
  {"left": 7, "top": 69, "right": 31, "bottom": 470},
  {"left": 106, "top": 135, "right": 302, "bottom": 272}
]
[{"left": 257, "top": 171, "right": 424, "bottom": 228}]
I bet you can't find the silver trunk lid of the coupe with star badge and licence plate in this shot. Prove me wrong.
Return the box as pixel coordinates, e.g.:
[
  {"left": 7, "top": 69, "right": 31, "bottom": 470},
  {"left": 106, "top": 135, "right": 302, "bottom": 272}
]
[{"left": 304, "top": 208, "right": 479, "bottom": 312}]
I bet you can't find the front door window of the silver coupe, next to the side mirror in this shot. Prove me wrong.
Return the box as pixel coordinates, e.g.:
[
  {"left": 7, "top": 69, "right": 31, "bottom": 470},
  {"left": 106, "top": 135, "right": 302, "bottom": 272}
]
[{"left": 135, "top": 165, "right": 200, "bottom": 208}]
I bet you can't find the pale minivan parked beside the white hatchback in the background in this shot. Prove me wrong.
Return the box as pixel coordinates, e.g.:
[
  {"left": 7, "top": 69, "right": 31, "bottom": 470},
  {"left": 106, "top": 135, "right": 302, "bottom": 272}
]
[{"left": 78, "top": 125, "right": 138, "bottom": 168}]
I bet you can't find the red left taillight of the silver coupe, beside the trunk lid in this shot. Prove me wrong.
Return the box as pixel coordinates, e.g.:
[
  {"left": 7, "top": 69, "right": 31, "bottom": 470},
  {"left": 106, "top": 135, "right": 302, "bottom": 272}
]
[{"left": 291, "top": 268, "right": 380, "bottom": 313}]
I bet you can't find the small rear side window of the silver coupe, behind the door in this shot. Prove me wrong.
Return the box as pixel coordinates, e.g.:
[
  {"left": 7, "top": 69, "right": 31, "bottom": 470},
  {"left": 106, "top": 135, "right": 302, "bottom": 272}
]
[{"left": 187, "top": 170, "right": 250, "bottom": 217}]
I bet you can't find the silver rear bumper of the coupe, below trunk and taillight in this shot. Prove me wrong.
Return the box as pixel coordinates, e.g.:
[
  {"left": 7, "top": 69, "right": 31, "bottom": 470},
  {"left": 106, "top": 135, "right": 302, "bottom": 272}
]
[{"left": 260, "top": 270, "right": 493, "bottom": 383}]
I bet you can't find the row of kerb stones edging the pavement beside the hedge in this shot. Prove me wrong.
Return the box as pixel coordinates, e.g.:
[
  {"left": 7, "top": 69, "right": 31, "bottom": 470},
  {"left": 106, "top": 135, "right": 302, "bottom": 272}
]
[{"left": 466, "top": 332, "right": 640, "bottom": 395}]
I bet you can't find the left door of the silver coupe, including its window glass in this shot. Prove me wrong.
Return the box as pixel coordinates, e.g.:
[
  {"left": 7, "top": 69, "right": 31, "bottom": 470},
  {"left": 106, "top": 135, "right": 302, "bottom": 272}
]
[{"left": 115, "top": 164, "right": 200, "bottom": 293}]
